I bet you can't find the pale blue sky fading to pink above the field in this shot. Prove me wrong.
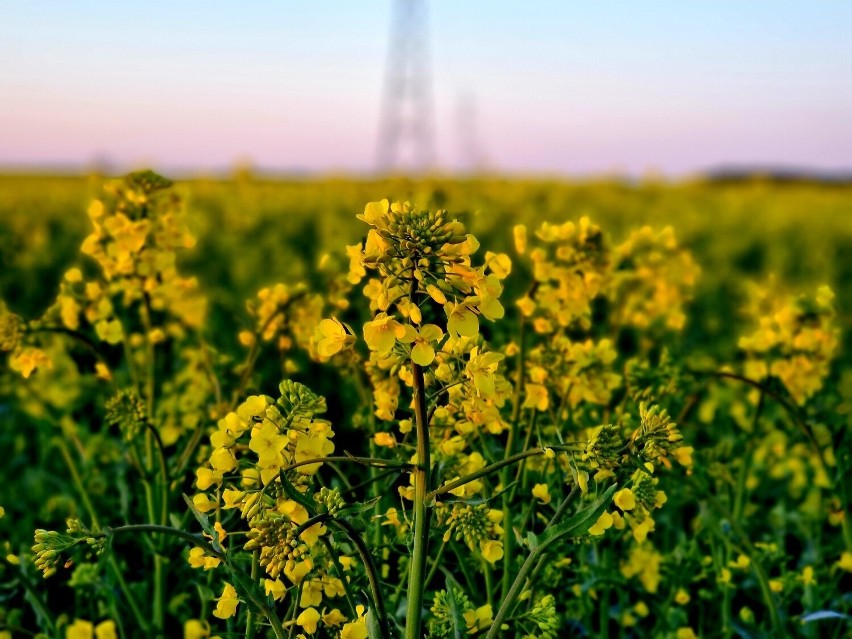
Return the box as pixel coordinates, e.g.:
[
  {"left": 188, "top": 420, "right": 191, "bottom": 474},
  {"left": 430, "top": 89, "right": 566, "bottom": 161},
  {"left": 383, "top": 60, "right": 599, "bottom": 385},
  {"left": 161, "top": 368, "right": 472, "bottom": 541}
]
[{"left": 0, "top": 0, "right": 852, "bottom": 176}]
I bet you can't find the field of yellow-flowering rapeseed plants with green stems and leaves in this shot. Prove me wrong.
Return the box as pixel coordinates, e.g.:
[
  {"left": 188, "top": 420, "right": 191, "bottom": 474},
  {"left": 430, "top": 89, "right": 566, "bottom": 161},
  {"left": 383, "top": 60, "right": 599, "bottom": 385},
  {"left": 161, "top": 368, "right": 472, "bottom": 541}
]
[{"left": 0, "top": 171, "right": 852, "bottom": 639}]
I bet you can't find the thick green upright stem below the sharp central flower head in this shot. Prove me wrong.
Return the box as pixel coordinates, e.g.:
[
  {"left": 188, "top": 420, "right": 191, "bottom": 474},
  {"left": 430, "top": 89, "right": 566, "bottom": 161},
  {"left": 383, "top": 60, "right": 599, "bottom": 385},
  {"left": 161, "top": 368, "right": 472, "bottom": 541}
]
[{"left": 405, "top": 362, "right": 430, "bottom": 639}]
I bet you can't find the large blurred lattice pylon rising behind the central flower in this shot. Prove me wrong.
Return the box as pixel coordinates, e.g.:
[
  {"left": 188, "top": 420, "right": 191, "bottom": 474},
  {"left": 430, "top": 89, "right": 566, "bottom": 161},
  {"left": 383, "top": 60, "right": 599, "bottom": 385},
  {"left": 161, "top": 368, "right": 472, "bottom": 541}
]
[{"left": 376, "top": 0, "right": 435, "bottom": 172}]
